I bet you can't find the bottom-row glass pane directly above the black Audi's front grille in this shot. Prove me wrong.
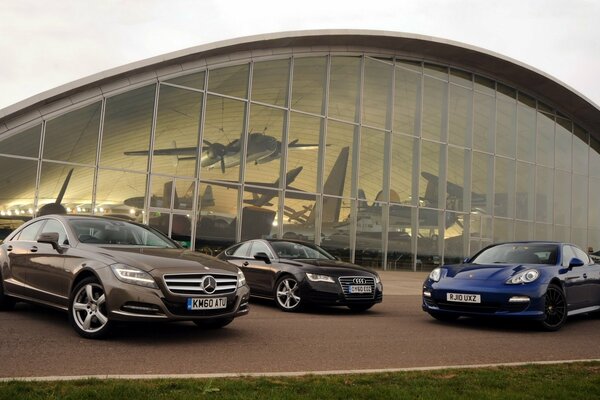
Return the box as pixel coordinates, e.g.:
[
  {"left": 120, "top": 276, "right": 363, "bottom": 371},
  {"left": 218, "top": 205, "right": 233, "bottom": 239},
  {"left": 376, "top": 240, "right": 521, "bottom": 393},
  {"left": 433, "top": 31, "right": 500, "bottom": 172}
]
[{"left": 354, "top": 201, "right": 387, "bottom": 268}]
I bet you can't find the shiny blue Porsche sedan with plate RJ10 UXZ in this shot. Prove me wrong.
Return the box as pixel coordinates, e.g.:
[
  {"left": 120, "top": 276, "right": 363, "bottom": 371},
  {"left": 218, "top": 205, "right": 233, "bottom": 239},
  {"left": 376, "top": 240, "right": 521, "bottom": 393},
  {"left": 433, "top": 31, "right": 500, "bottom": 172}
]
[{"left": 423, "top": 242, "right": 600, "bottom": 331}]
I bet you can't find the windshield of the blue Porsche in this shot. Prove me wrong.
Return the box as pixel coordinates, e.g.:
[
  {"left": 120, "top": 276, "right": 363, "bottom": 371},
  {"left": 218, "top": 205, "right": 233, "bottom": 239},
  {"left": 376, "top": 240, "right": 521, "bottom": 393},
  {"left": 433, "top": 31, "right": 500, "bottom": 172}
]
[{"left": 471, "top": 243, "right": 558, "bottom": 265}]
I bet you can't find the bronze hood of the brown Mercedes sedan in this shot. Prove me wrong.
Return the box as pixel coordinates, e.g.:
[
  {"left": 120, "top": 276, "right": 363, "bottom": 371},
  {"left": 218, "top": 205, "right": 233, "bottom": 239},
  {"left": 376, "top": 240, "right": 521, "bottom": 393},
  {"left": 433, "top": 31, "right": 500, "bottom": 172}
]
[{"left": 82, "top": 246, "right": 237, "bottom": 273}]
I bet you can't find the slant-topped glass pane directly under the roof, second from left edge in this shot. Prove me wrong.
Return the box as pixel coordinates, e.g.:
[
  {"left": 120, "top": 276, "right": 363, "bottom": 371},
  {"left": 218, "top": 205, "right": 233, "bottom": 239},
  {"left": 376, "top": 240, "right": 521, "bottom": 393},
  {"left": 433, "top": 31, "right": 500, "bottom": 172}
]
[{"left": 42, "top": 102, "right": 102, "bottom": 165}]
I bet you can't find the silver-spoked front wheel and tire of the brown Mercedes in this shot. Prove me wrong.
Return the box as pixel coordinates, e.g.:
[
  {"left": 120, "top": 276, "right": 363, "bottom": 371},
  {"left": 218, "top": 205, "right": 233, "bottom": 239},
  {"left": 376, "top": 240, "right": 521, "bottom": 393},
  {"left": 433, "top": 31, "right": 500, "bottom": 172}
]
[{"left": 69, "top": 277, "right": 113, "bottom": 339}]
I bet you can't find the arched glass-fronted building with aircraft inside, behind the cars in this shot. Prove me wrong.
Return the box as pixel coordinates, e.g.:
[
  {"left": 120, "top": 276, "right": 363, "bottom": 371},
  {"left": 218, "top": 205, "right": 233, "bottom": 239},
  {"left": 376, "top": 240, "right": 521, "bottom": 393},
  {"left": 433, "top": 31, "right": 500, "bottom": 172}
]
[{"left": 0, "top": 31, "right": 600, "bottom": 270}]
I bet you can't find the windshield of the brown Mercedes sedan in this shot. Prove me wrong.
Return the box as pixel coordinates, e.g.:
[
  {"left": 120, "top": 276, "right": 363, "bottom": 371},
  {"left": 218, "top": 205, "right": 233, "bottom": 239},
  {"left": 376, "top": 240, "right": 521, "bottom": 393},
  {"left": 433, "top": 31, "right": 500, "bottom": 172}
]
[{"left": 69, "top": 218, "right": 177, "bottom": 248}]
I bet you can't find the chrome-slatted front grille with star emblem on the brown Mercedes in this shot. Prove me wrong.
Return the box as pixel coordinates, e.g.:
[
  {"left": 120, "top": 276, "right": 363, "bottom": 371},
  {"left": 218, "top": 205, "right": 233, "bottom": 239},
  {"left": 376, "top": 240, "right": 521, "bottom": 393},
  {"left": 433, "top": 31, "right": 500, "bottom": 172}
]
[{"left": 163, "top": 274, "right": 237, "bottom": 296}]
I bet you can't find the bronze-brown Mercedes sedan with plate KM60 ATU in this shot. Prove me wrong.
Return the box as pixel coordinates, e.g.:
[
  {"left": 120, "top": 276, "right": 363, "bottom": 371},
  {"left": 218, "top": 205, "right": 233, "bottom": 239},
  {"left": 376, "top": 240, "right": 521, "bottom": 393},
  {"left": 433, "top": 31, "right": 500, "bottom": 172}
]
[{"left": 0, "top": 215, "right": 250, "bottom": 339}]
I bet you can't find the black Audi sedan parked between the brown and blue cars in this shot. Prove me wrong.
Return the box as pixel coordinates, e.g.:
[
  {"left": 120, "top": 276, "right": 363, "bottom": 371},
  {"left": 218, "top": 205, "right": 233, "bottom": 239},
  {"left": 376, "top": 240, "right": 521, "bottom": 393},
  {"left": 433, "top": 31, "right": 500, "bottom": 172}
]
[{"left": 217, "top": 239, "right": 383, "bottom": 311}]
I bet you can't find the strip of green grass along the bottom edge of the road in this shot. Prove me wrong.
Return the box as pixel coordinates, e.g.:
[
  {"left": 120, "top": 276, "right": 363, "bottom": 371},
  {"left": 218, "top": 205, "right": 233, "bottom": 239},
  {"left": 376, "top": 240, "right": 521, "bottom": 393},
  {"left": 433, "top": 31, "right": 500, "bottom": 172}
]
[{"left": 0, "top": 362, "right": 600, "bottom": 400}]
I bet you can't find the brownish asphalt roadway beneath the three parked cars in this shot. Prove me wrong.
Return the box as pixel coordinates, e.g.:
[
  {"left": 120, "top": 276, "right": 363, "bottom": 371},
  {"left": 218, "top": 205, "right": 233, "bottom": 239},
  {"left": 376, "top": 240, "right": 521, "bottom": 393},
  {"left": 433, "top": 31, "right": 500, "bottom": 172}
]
[{"left": 0, "top": 294, "right": 600, "bottom": 378}]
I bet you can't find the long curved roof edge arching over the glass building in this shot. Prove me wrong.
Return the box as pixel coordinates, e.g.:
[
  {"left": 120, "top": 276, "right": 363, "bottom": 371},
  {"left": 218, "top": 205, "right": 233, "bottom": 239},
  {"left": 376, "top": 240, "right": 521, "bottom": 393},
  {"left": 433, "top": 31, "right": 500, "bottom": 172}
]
[{"left": 0, "top": 30, "right": 600, "bottom": 135}]
